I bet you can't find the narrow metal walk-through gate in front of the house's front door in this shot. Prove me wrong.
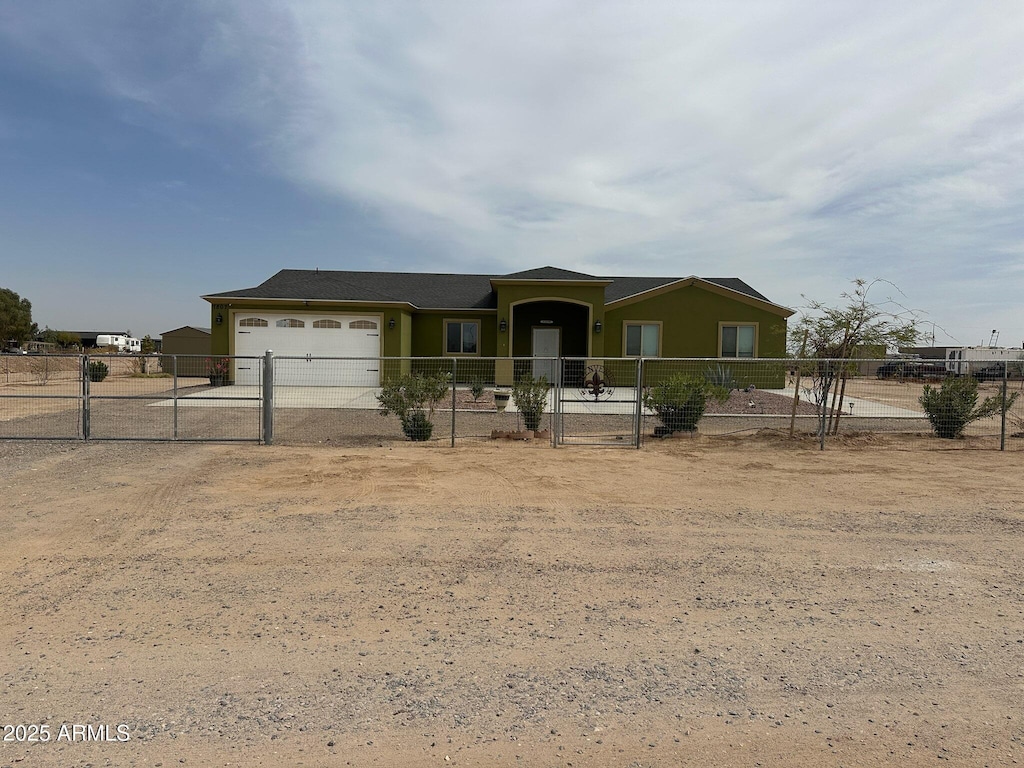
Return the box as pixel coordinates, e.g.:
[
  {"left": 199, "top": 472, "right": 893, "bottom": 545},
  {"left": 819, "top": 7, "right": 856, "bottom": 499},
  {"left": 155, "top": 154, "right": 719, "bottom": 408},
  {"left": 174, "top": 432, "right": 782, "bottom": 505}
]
[{"left": 553, "top": 357, "right": 643, "bottom": 449}]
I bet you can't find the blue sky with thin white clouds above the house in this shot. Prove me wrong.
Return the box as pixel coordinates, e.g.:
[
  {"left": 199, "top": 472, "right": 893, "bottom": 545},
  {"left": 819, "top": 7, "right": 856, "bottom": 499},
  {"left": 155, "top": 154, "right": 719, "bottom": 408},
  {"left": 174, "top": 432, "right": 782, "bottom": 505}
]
[{"left": 0, "top": 0, "right": 1024, "bottom": 345}]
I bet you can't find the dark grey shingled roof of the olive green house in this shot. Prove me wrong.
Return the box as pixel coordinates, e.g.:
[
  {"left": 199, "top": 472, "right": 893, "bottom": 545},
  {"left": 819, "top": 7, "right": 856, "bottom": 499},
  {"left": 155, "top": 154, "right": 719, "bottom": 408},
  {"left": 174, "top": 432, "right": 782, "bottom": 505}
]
[{"left": 204, "top": 266, "right": 774, "bottom": 309}]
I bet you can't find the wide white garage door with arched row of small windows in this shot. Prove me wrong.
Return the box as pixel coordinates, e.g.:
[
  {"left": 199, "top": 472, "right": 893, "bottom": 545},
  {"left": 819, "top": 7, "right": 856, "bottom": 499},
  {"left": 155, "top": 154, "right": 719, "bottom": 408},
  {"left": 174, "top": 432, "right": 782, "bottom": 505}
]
[{"left": 234, "top": 312, "right": 381, "bottom": 387}]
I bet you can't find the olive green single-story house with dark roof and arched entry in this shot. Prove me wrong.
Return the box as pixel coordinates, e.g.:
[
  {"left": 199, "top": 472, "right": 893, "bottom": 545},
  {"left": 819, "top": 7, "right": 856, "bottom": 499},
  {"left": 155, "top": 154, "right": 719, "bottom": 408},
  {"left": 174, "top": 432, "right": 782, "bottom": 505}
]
[{"left": 203, "top": 266, "right": 793, "bottom": 386}]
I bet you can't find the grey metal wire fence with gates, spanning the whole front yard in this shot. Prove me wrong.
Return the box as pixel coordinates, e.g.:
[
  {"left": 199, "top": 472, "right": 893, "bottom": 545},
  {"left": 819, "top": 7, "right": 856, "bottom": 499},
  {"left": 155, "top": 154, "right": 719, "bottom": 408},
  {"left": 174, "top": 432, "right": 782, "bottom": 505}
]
[{"left": 0, "top": 354, "right": 1024, "bottom": 450}]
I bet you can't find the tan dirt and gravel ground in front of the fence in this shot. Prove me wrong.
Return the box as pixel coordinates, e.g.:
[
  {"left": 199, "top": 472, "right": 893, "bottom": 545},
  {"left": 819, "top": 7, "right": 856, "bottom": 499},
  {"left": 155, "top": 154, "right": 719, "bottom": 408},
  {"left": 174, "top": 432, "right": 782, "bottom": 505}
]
[{"left": 0, "top": 436, "right": 1024, "bottom": 767}]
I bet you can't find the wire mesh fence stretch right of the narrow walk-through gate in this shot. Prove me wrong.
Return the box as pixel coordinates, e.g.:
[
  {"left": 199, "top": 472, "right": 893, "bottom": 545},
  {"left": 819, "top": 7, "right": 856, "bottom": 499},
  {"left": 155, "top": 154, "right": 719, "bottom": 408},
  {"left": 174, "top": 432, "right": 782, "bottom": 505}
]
[{"left": 642, "top": 358, "right": 1024, "bottom": 450}]
